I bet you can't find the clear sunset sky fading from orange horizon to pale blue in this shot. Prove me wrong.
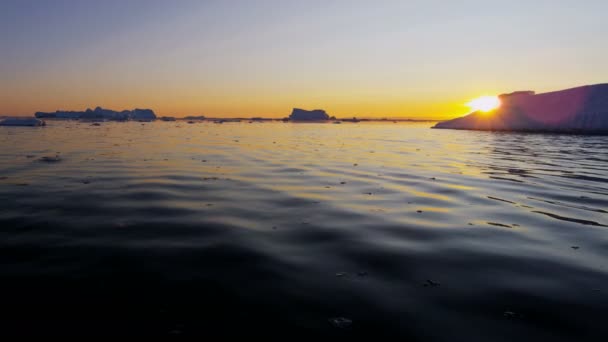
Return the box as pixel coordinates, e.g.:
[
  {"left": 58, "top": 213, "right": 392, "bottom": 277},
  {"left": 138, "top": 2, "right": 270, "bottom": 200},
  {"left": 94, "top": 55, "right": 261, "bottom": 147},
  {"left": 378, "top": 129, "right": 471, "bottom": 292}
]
[{"left": 0, "top": 0, "right": 608, "bottom": 119}]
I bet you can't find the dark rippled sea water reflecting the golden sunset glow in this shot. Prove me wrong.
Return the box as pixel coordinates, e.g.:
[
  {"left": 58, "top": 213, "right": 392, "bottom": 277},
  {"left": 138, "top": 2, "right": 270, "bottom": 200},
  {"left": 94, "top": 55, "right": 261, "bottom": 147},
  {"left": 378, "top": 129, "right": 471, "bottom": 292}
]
[{"left": 0, "top": 122, "right": 608, "bottom": 341}]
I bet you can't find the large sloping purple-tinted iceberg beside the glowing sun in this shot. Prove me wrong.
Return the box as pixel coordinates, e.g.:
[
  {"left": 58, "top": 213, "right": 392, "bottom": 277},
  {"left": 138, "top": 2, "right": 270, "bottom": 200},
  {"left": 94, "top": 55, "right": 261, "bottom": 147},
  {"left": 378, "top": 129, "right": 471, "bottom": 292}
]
[{"left": 434, "top": 84, "right": 608, "bottom": 133}]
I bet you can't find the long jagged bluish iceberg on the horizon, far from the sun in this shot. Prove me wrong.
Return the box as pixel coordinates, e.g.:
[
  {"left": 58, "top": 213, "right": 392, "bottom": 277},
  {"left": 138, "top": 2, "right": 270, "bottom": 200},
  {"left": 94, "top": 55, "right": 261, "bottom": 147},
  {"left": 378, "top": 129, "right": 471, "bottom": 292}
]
[{"left": 35, "top": 107, "right": 156, "bottom": 121}]
